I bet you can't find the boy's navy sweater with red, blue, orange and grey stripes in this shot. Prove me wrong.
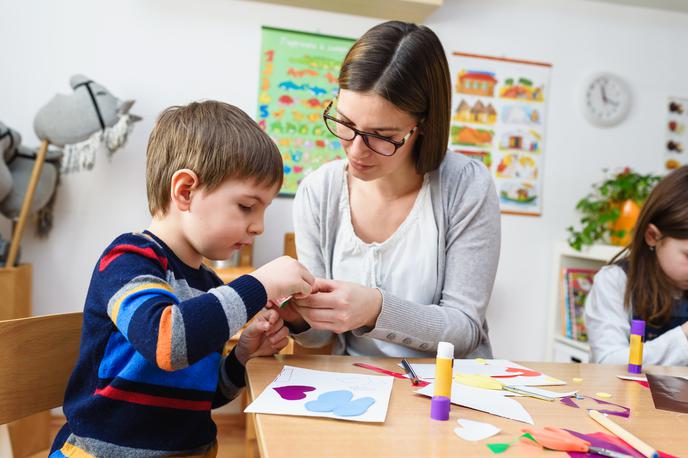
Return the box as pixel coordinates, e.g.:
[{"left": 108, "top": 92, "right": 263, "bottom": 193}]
[{"left": 50, "top": 231, "right": 267, "bottom": 458}]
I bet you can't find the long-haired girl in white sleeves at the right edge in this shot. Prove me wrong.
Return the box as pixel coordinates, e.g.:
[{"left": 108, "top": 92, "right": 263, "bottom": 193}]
[{"left": 585, "top": 166, "right": 688, "bottom": 366}]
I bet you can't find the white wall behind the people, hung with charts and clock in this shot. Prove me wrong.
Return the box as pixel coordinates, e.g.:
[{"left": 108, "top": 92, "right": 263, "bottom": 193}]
[{"left": 0, "top": 0, "right": 688, "bottom": 360}]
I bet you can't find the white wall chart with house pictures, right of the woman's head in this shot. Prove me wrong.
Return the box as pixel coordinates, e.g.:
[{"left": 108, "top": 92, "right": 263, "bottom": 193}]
[{"left": 449, "top": 52, "right": 551, "bottom": 216}]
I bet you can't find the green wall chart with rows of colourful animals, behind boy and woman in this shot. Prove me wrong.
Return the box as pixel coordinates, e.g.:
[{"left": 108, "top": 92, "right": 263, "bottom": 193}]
[{"left": 256, "top": 27, "right": 354, "bottom": 196}]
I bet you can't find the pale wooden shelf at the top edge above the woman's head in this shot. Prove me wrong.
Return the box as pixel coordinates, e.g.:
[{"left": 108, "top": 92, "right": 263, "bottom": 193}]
[{"left": 245, "top": 0, "right": 444, "bottom": 23}]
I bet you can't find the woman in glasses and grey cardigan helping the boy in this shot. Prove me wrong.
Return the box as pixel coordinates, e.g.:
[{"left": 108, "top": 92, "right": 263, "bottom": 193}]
[{"left": 282, "top": 21, "right": 500, "bottom": 358}]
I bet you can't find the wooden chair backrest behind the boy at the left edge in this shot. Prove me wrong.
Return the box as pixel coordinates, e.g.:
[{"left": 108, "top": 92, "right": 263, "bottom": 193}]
[{"left": 0, "top": 312, "right": 83, "bottom": 425}]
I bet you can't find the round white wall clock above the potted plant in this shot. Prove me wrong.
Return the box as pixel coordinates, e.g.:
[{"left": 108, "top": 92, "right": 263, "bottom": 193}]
[{"left": 583, "top": 73, "right": 631, "bottom": 126}]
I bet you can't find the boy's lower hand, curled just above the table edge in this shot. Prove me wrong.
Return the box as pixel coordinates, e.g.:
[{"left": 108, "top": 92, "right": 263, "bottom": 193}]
[{"left": 235, "top": 310, "right": 289, "bottom": 366}]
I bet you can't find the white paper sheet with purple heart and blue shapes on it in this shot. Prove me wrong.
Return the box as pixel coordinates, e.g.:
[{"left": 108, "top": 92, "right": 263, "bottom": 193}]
[{"left": 244, "top": 366, "right": 394, "bottom": 423}]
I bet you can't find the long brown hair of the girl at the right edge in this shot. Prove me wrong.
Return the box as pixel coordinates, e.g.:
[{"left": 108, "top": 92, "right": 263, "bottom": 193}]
[{"left": 611, "top": 166, "right": 688, "bottom": 324}]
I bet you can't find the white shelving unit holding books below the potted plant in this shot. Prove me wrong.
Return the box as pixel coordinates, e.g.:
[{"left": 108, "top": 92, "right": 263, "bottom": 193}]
[{"left": 546, "top": 241, "right": 622, "bottom": 363}]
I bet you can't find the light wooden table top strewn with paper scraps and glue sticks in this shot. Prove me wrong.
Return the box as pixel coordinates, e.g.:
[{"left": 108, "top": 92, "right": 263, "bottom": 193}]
[{"left": 247, "top": 355, "right": 688, "bottom": 458}]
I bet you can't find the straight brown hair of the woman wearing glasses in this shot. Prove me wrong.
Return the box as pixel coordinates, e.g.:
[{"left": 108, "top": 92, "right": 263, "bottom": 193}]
[{"left": 339, "top": 21, "right": 451, "bottom": 174}]
